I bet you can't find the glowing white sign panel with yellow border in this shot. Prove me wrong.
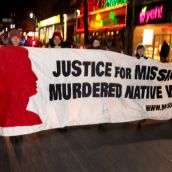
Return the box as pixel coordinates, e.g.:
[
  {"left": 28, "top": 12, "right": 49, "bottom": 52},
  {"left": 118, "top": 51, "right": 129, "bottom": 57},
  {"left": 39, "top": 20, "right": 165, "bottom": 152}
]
[{"left": 39, "top": 15, "right": 60, "bottom": 28}]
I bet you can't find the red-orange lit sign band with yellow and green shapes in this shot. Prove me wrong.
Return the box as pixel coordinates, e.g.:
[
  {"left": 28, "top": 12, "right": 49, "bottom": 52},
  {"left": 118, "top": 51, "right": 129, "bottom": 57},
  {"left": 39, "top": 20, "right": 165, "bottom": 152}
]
[{"left": 77, "top": 4, "right": 127, "bottom": 32}]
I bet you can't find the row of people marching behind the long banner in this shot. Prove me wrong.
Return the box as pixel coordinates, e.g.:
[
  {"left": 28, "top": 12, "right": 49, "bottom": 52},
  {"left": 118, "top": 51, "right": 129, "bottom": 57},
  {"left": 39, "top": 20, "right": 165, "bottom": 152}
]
[{"left": 1, "top": 29, "right": 170, "bottom": 63}]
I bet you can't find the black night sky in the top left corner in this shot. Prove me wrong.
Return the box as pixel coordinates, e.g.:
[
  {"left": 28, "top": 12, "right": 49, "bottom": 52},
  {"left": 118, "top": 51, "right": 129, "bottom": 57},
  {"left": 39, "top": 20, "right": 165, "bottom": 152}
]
[{"left": 0, "top": 0, "right": 36, "bottom": 18}]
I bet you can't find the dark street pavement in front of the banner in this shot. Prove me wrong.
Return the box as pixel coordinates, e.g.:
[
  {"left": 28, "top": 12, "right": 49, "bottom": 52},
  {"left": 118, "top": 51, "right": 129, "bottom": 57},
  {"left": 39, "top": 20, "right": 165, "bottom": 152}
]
[{"left": 0, "top": 121, "right": 172, "bottom": 172}]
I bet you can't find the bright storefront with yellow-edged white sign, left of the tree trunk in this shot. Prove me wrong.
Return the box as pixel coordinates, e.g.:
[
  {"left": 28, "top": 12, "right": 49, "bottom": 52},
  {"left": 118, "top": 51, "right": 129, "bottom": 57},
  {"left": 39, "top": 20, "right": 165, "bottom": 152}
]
[{"left": 39, "top": 15, "right": 62, "bottom": 43}]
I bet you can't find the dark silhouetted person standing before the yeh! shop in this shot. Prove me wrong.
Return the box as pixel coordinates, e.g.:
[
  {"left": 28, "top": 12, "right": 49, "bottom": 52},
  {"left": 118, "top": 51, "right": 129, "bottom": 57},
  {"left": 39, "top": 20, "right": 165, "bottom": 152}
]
[{"left": 160, "top": 40, "right": 170, "bottom": 63}]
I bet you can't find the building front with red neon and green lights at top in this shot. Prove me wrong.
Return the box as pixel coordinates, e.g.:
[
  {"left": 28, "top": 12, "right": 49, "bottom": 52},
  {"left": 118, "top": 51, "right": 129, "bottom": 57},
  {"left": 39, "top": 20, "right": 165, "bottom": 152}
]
[{"left": 76, "top": 0, "right": 128, "bottom": 51}]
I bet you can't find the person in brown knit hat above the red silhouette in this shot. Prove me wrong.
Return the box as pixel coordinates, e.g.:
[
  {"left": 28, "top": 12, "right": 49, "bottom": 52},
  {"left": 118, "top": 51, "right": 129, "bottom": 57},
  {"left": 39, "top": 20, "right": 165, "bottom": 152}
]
[{"left": 9, "top": 29, "right": 21, "bottom": 46}]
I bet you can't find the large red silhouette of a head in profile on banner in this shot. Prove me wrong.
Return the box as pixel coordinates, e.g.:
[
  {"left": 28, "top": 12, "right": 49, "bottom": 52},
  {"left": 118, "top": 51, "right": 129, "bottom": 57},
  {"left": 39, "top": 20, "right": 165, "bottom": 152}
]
[{"left": 0, "top": 46, "right": 42, "bottom": 127}]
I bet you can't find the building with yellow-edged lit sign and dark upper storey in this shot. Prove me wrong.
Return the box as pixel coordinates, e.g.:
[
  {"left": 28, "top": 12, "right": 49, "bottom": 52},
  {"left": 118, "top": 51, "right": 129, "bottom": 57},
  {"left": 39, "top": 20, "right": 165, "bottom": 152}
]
[{"left": 37, "top": 0, "right": 77, "bottom": 43}]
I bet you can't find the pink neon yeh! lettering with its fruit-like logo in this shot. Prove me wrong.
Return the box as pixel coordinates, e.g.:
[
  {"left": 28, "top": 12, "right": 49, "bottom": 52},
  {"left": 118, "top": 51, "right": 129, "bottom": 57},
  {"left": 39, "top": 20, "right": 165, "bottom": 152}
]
[{"left": 139, "top": 5, "right": 164, "bottom": 24}]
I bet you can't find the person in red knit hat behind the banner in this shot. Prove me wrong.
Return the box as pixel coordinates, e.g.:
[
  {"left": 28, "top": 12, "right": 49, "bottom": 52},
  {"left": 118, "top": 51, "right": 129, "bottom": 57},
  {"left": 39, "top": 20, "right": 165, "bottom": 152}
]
[{"left": 50, "top": 32, "right": 63, "bottom": 48}]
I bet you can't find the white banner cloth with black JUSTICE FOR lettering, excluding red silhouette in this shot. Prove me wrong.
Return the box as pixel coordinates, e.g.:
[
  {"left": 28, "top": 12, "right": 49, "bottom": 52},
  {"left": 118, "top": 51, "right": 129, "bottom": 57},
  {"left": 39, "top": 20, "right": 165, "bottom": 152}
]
[{"left": 0, "top": 48, "right": 172, "bottom": 135}]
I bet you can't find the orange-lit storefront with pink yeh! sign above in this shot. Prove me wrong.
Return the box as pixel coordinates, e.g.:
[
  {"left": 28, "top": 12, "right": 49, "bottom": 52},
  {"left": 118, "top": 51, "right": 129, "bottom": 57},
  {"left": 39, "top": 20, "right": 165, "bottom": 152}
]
[{"left": 133, "top": 1, "right": 172, "bottom": 61}]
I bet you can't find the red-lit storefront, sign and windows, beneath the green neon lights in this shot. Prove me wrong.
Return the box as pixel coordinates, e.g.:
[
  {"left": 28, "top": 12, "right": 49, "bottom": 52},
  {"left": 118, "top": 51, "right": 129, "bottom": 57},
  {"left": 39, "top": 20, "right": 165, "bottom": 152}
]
[{"left": 76, "top": 1, "right": 128, "bottom": 47}]
